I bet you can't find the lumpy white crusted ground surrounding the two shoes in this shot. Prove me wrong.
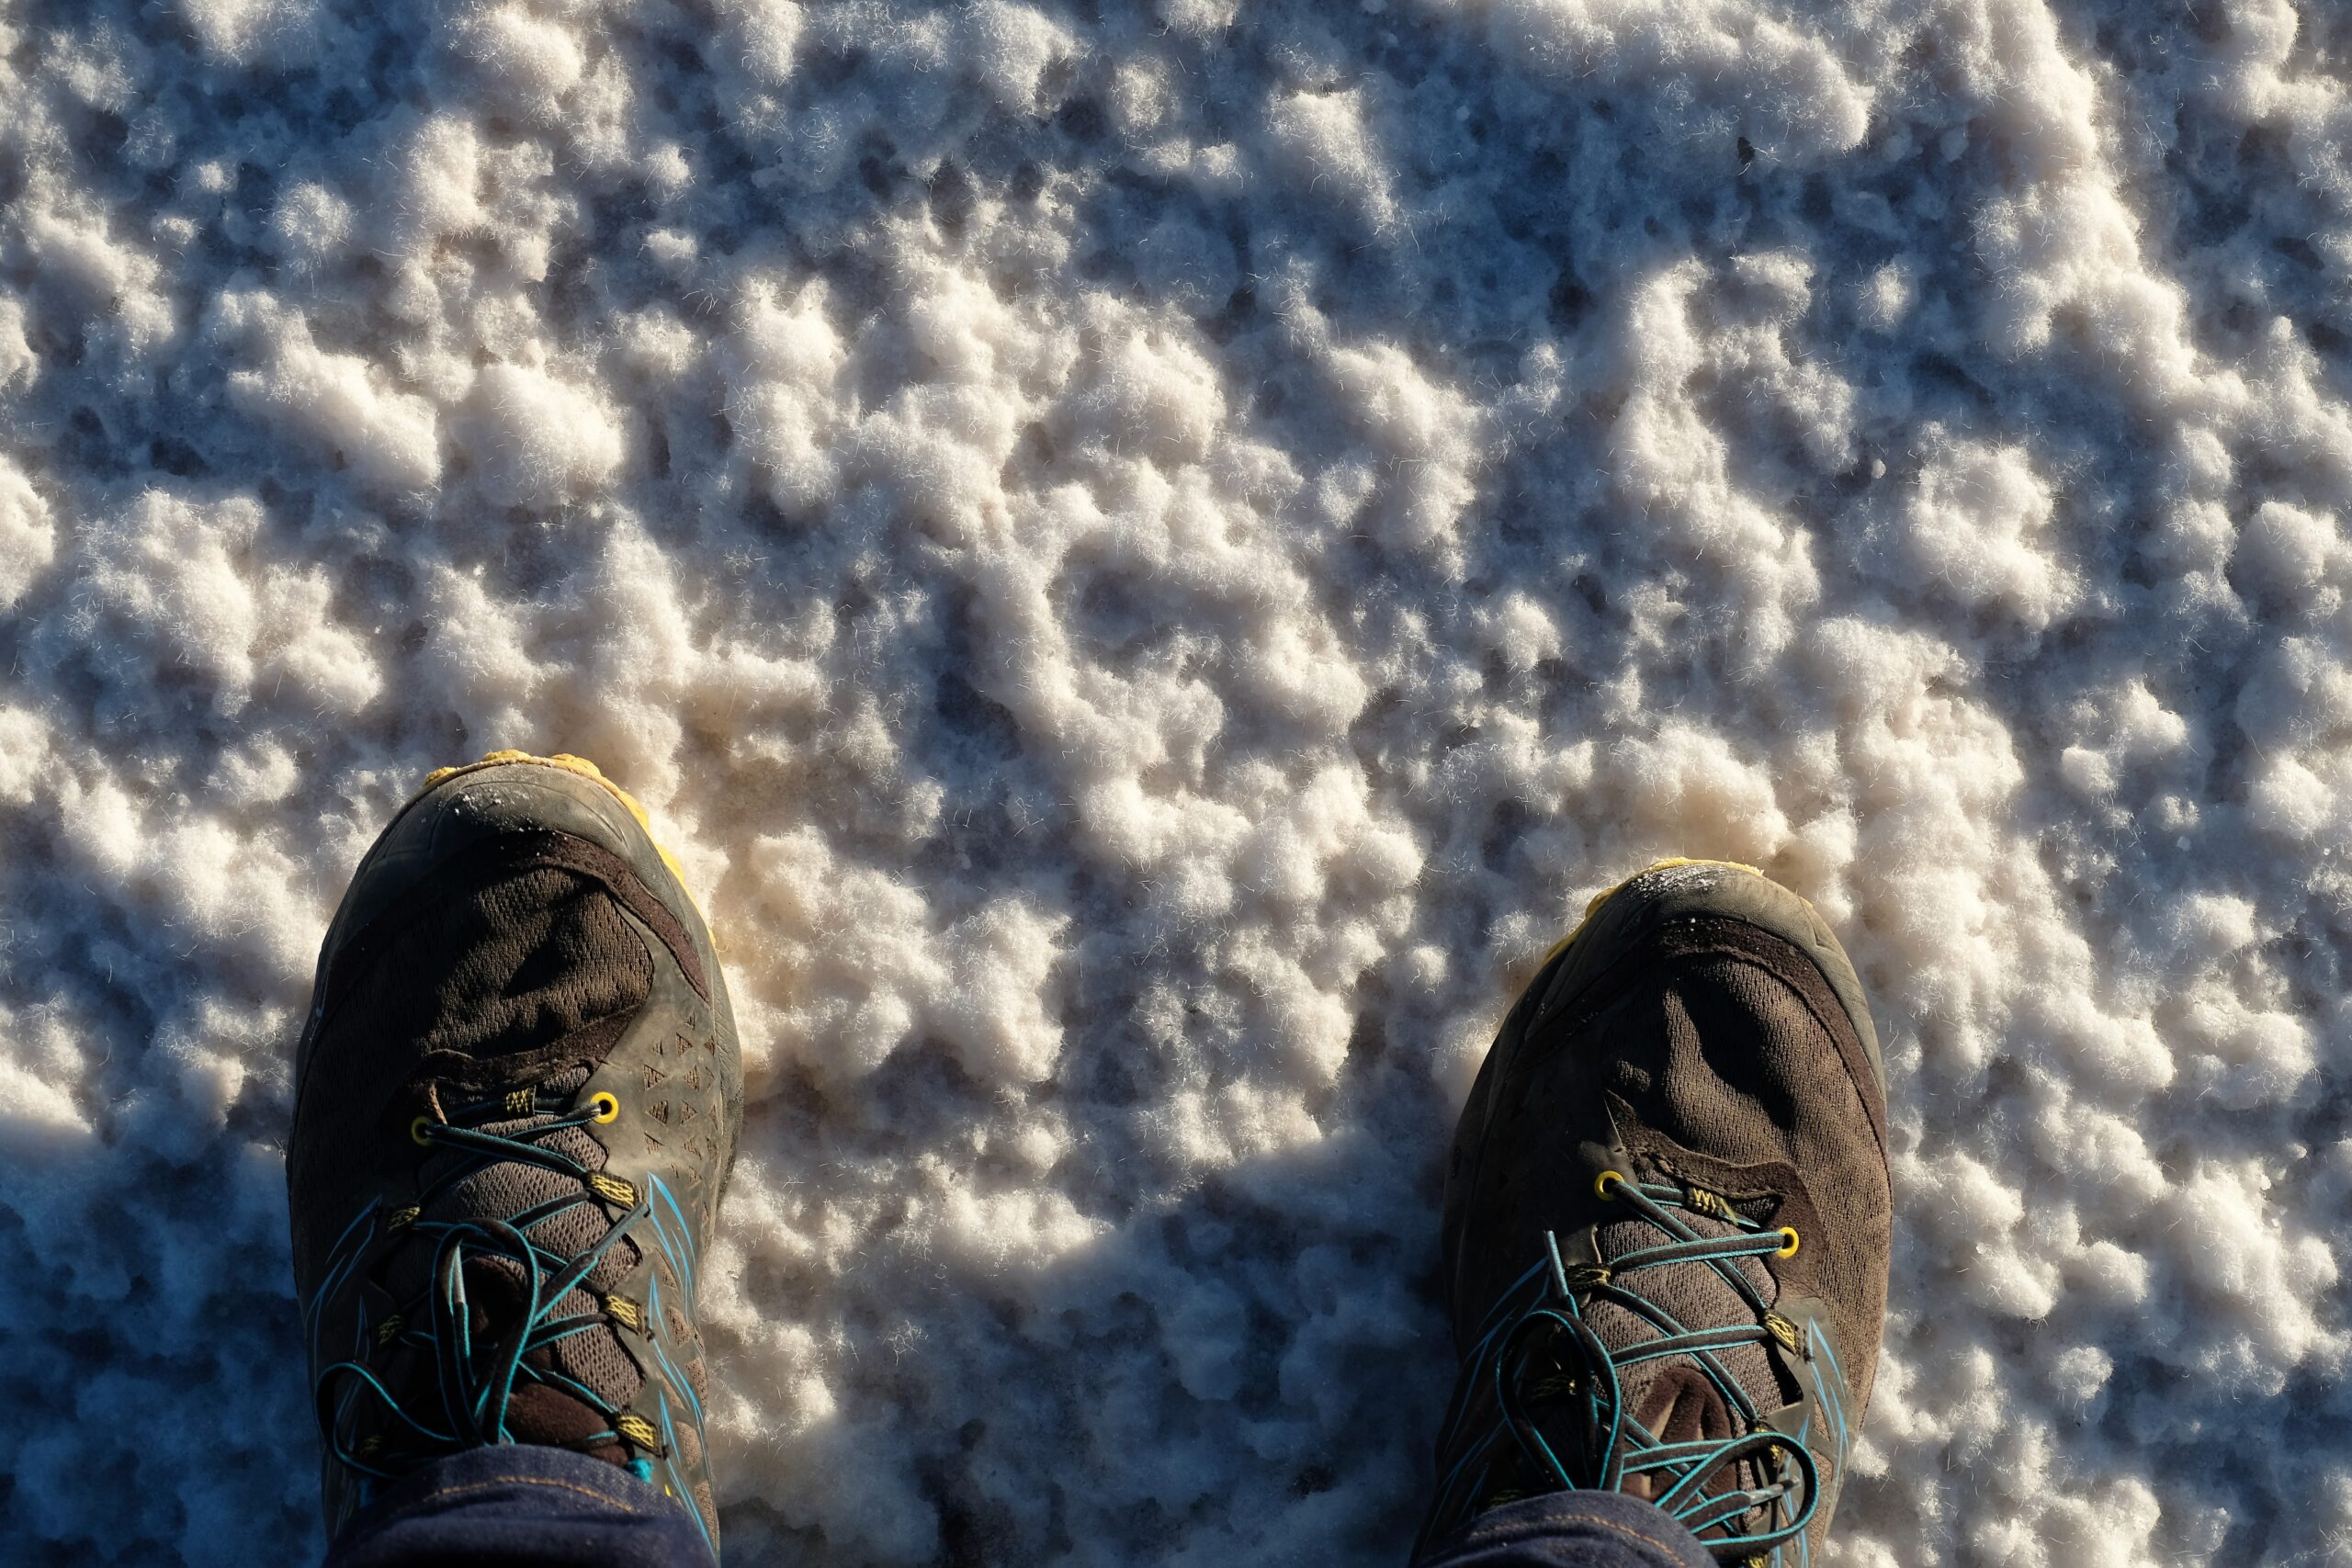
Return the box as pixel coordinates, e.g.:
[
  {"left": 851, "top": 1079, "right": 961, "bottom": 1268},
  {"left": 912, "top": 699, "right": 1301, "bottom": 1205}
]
[{"left": 0, "top": 0, "right": 2352, "bottom": 1568}]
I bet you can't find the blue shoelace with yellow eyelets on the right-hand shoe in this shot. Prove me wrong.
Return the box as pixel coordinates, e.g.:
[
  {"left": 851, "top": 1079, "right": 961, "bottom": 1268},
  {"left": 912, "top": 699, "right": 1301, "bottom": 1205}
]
[{"left": 1414, "top": 1170, "right": 1818, "bottom": 1561}]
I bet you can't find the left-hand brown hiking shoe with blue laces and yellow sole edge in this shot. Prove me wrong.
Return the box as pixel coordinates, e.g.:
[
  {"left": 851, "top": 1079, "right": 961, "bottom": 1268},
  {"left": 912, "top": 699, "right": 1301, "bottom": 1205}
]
[{"left": 287, "top": 752, "right": 743, "bottom": 1556}]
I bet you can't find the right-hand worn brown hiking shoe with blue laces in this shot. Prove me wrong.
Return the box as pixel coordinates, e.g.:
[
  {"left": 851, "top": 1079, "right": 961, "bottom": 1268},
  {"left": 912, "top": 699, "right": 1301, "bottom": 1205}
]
[{"left": 1416, "top": 861, "right": 1891, "bottom": 1563}]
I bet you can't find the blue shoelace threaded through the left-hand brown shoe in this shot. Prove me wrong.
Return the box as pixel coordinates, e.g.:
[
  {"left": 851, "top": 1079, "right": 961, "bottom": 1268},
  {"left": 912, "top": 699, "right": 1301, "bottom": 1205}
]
[{"left": 306, "top": 1089, "right": 665, "bottom": 1481}]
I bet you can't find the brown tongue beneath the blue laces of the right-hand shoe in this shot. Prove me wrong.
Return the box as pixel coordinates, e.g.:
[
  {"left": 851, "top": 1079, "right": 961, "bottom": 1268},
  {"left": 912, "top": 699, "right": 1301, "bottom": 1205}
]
[{"left": 1585, "top": 1213, "right": 1788, "bottom": 1441}]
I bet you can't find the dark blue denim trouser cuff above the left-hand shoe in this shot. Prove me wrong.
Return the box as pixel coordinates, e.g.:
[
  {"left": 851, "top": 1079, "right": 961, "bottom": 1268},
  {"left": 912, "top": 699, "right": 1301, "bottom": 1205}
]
[{"left": 327, "top": 1443, "right": 710, "bottom": 1568}]
